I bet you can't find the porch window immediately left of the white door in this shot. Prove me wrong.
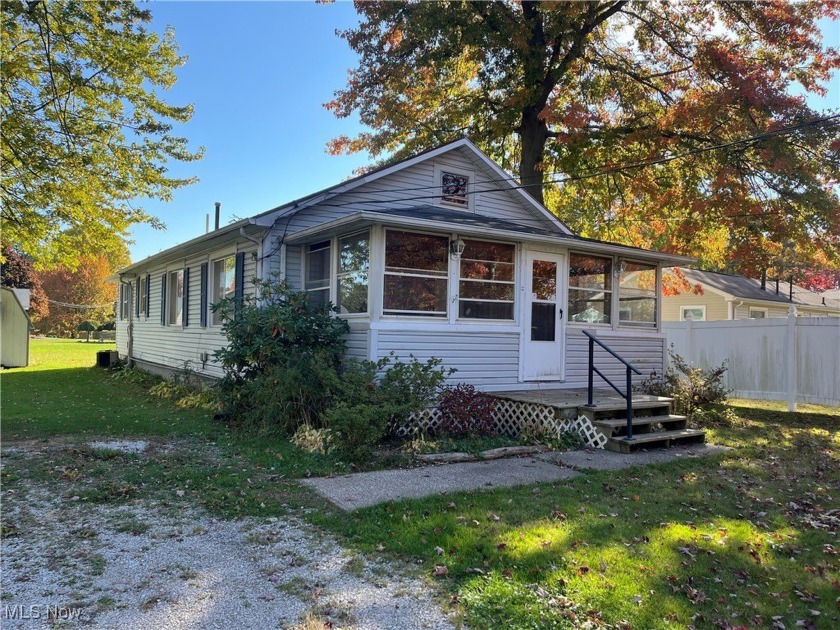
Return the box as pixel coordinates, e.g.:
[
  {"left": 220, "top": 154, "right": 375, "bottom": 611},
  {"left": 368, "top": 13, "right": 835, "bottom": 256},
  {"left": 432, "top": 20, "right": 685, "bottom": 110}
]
[{"left": 458, "top": 241, "right": 516, "bottom": 320}]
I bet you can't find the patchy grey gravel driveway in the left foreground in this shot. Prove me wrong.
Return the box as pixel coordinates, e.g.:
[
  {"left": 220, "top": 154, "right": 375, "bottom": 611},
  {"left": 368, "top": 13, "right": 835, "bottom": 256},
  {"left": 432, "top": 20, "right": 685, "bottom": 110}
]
[{"left": 0, "top": 450, "right": 453, "bottom": 630}]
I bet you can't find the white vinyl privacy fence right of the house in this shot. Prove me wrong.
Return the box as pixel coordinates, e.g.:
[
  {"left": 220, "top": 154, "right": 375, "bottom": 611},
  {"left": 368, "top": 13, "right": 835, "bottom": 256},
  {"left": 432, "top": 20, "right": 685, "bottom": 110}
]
[{"left": 662, "top": 307, "right": 840, "bottom": 411}]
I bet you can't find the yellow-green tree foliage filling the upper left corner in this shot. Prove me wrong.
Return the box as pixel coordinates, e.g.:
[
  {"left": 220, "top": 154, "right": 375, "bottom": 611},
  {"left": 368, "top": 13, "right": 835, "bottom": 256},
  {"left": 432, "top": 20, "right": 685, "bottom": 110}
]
[{"left": 0, "top": 0, "right": 203, "bottom": 268}]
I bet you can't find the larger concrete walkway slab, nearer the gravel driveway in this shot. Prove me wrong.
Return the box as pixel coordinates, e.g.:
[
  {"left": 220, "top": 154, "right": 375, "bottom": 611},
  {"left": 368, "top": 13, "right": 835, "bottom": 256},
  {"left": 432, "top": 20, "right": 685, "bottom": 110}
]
[{"left": 301, "top": 458, "right": 580, "bottom": 510}]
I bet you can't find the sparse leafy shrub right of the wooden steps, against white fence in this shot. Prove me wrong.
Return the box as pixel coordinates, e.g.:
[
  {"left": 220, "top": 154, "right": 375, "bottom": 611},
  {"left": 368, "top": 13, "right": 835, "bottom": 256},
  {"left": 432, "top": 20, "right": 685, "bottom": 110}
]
[{"left": 639, "top": 347, "right": 731, "bottom": 422}]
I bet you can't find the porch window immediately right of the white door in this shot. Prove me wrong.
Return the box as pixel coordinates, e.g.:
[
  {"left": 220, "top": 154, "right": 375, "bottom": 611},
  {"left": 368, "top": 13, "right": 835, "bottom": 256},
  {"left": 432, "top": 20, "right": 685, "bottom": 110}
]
[{"left": 569, "top": 254, "right": 612, "bottom": 324}]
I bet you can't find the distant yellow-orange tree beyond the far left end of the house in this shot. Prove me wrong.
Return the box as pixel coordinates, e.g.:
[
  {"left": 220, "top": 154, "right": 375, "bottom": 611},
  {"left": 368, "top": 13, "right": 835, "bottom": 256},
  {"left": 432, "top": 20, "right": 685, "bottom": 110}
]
[{"left": 36, "top": 255, "right": 117, "bottom": 336}]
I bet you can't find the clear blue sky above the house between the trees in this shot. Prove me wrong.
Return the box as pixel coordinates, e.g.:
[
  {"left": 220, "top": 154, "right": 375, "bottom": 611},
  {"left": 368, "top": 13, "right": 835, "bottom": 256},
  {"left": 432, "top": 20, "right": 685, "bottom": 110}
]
[{"left": 130, "top": 0, "right": 840, "bottom": 261}]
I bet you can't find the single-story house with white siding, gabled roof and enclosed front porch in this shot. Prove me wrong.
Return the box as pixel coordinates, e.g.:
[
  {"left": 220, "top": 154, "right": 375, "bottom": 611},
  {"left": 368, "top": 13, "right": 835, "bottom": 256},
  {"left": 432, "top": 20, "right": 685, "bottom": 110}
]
[{"left": 117, "top": 139, "right": 690, "bottom": 391}]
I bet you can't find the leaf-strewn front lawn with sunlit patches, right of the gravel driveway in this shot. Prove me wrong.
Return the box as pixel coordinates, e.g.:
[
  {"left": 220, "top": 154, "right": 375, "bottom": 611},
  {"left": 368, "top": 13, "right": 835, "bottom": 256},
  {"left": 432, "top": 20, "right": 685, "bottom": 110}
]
[{"left": 315, "top": 401, "right": 840, "bottom": 629}]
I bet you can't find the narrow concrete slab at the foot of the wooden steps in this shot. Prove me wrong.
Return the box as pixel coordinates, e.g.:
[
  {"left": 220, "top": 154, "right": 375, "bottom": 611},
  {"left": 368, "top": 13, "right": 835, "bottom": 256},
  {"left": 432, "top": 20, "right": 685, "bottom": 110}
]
[{"left": 534, "top": 444, "right": 729, "bottom": 470}]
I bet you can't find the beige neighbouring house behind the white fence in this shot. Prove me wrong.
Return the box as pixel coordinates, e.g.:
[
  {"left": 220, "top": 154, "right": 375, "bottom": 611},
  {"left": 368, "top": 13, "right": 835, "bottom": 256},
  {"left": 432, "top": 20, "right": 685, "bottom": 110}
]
[{"left": 662, "top": 269, "right": 840, "bottom": 322}]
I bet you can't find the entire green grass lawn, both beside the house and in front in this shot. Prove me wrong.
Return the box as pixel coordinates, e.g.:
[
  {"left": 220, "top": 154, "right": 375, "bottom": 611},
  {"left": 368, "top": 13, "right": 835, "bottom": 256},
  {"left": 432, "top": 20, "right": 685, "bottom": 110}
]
[{"left": 0, "top": 340, "right": 840, "bottom": 629}]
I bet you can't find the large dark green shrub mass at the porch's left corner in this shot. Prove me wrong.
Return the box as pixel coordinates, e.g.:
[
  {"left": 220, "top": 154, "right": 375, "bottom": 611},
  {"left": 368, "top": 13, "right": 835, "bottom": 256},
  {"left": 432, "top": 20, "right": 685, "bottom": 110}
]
[{"left": 214, "top": 282, "right": 451, "bottom": 461}]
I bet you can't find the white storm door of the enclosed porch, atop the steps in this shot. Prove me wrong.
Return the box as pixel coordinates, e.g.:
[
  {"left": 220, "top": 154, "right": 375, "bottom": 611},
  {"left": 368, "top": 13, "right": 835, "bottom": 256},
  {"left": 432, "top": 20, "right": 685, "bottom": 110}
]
[{"left": 522, "top": 252, "right": 566, "bottom": 381}]
